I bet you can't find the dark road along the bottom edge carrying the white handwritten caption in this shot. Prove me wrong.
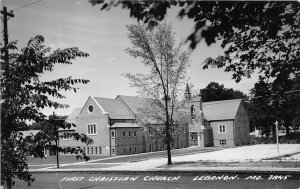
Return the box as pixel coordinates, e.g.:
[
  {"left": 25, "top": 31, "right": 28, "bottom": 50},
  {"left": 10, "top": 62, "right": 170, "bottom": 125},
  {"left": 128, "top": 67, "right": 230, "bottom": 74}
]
[{"left": 15, "top": 172, "right": 300, "bottom": 189}]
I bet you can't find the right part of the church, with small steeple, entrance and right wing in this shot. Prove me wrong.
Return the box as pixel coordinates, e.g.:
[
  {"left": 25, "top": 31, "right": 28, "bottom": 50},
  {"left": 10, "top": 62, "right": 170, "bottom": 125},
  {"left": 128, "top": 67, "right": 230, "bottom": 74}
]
[{"left": 185, "top": 85, "right": 251, "bottom": 148}]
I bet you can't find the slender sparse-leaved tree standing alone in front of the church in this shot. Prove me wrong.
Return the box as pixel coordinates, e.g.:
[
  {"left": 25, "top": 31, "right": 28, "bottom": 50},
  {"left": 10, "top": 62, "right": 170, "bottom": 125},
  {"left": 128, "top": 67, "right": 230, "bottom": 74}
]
[{"left": 125, "top": 24, "right": 190, "bottom": 165}]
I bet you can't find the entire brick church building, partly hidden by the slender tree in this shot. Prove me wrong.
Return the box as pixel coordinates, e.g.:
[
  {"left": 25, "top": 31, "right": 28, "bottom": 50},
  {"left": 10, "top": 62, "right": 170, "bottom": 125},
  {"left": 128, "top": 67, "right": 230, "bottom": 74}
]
[{"left": 59, "top": 86, "right": 250, "bottom": 156}]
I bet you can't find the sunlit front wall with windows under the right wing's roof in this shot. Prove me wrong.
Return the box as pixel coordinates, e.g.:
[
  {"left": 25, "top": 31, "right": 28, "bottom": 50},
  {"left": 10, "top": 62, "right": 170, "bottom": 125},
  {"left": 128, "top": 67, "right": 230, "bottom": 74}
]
[{"left": 210, "top": 120, "right": 234, "bottom": 147}]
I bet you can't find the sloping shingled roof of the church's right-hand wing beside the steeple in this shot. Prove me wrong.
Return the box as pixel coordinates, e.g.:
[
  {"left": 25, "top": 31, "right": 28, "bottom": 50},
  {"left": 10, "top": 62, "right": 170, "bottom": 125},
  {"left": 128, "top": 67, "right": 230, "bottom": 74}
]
[{"left": 203, "top": 99, "right": 242, "bottom": 121}]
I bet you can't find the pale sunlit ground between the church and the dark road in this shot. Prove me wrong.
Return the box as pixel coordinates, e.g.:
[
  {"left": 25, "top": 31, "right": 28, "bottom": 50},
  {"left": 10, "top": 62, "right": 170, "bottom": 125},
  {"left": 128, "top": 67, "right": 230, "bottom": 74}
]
[{"left": 31, "top": 144, "right": 300, "bottom": 173}]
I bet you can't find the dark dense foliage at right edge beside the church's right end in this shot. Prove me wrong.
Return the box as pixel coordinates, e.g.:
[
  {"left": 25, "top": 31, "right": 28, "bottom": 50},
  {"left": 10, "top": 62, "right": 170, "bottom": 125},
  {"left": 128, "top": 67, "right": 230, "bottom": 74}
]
[{"left": 247, "top": 79, "right": 300, "bottom": 138}]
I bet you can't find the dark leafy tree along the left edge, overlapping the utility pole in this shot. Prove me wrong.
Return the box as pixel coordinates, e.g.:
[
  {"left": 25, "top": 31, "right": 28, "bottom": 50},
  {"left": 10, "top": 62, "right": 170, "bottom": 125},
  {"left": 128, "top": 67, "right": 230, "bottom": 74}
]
[{"left": 1, "top": 35, "right": 90, "bottom": 188}]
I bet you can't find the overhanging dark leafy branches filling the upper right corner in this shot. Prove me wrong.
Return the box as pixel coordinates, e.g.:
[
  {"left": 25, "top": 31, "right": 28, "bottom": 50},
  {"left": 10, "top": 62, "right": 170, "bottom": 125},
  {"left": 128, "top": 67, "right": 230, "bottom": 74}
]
[{"left": 90, "top": 0, "right": 300, "bottom": 137}]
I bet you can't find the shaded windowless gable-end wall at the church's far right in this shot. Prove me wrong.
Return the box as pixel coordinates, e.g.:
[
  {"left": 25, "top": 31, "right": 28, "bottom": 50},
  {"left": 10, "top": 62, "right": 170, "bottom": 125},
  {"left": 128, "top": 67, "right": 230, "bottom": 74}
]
[{"left": 234, "top": 104, "right": 251, "bottom": 146}]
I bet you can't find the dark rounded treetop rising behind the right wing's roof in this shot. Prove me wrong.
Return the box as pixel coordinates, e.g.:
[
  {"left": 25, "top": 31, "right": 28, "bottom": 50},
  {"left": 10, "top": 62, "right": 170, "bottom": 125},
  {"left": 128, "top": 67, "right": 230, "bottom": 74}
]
[{"left": 200, "top": 82, "right": 246, "bottom": 102}]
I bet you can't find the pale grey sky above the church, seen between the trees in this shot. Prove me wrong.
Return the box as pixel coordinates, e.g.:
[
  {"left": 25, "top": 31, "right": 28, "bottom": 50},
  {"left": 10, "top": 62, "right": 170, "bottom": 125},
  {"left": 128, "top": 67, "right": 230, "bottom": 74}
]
[{"left": 1, "top": 0, "right": 257, "bottom": 115}]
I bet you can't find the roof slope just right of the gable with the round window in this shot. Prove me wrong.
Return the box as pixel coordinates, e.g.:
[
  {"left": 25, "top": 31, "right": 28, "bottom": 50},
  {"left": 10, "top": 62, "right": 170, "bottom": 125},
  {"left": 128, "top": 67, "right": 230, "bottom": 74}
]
[{"left": 94, "top": 97, "right": 134, "bottom": 119}]
